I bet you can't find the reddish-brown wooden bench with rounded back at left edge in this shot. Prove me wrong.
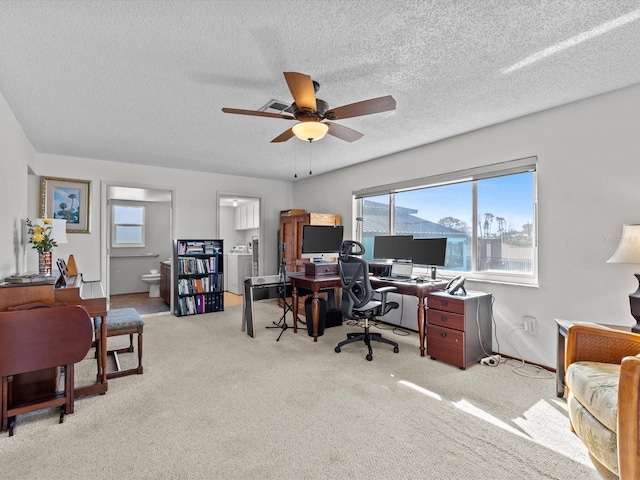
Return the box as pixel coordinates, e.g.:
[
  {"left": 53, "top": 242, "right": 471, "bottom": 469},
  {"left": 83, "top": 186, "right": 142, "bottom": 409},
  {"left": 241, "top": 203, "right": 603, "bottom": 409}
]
[{"left": 0, "top": 304, "right": 93, "bottom": 436}]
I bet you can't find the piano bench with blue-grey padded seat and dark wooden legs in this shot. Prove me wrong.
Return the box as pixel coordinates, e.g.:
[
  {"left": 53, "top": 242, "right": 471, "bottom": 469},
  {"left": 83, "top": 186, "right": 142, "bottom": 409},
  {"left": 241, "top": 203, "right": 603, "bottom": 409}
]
[{"left": 94, "top": 308, "right": 144, "bottom": 378}]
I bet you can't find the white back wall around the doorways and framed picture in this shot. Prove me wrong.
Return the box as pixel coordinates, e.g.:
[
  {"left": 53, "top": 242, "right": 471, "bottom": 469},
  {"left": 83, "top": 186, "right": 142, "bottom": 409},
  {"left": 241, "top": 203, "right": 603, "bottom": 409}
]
[{"left": 23, "top": 154, "right": 291, "bottom": 290}]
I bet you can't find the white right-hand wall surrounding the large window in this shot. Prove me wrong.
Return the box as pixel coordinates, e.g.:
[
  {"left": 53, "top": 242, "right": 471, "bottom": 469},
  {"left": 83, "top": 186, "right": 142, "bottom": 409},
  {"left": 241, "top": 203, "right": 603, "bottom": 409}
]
[{"left": 293, "top": 85, "right": 640, "bottom": 367}]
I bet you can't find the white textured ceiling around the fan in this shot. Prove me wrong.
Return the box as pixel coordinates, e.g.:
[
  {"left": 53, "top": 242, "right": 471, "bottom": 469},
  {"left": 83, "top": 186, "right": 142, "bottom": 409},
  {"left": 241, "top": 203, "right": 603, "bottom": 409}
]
[{"left": 0, "top": 0, "right": 640, "bottom": 180}]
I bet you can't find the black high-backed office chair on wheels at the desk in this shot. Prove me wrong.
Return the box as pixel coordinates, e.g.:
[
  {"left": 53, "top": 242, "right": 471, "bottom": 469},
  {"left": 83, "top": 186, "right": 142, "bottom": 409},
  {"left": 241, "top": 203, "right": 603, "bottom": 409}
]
[{"left": 335, "top": 240, "right": 399, "bottom": 360}]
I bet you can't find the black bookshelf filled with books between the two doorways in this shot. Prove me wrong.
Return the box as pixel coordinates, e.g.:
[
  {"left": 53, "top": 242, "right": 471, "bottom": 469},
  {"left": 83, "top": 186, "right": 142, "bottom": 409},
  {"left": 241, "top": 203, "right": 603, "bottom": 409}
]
[{"left": 173, "top": 240, "right": 224, "bottom": 317}]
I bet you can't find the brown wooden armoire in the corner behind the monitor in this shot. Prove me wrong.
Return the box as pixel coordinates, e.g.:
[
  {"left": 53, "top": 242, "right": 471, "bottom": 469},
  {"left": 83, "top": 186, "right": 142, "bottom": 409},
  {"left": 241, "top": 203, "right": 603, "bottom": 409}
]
[{"left": 280, "top": 210, "right": 340, "bottom": 272}]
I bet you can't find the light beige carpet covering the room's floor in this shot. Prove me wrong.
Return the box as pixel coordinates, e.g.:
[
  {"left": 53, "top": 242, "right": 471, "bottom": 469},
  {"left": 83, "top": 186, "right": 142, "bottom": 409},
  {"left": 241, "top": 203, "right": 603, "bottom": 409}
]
[{"left": 0, "top": 300, "right": 607, "bottom": 480}]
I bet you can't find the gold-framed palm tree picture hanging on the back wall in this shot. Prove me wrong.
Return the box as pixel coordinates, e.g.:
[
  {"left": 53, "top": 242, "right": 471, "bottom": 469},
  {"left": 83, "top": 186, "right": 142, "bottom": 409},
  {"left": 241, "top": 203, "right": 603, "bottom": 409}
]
[{"left": 40, "top": 177, "right": 91, "bottom": 233}]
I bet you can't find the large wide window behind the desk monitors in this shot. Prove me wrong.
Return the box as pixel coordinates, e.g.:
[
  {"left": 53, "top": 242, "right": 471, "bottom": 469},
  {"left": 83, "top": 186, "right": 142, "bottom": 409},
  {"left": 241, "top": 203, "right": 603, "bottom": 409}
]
[{"left": 355, "top": 158, "right": 537, "bottom": 284}]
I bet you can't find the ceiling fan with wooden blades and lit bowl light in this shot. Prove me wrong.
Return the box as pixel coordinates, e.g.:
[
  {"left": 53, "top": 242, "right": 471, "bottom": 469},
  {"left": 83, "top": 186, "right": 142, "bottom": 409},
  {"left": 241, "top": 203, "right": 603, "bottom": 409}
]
[{"left": 222, "top": 72, "right": 396, "bottom": 143}]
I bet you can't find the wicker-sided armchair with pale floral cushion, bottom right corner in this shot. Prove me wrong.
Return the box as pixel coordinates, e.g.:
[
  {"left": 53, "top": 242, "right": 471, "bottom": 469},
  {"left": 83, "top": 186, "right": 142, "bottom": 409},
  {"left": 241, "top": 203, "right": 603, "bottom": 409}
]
[{"left": 565, "top": 323, "right": 640, "bottom": 480}]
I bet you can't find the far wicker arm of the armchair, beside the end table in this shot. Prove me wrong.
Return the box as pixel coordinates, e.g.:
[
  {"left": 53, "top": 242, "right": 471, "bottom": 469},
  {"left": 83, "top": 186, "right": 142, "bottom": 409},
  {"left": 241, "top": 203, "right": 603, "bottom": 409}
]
[{"left": 565, "top": 323, "right": 640, "bottom": 371}]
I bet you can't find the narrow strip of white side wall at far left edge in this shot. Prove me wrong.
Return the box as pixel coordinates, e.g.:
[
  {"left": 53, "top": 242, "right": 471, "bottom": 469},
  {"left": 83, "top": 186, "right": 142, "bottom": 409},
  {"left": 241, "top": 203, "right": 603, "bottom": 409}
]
[{"left": 0, "top": 94, "right": 37, "bottom": 280}]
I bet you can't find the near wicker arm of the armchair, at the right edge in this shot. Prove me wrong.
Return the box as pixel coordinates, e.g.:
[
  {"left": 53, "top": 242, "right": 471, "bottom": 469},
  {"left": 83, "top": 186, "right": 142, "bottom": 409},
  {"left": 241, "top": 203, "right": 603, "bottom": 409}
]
[{"left": 617, "top": 357, "right": 640, "bottom": 478}]
